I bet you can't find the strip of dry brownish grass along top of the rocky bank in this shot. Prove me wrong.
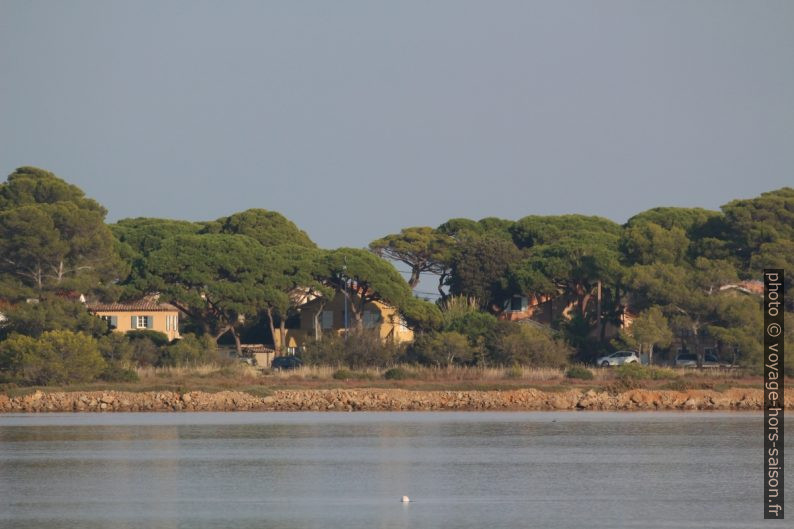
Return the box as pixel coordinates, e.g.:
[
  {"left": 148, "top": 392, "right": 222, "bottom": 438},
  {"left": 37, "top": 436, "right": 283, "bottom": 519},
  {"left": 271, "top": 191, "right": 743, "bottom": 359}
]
[{"left": 0, "top": 364, "right": 768, "bottom": 395}]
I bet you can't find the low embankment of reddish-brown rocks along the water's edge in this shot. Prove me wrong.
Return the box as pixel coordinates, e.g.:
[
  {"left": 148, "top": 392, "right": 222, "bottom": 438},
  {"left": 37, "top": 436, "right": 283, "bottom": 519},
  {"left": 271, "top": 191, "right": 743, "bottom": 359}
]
[{"left": 0, "top": 389, "right": 794, "bottom": 413}]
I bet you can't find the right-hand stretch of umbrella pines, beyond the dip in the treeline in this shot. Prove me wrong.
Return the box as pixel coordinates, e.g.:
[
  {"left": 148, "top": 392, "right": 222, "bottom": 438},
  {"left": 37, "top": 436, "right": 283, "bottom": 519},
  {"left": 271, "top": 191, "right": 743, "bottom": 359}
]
[{"left": 370, "top": 188, "right": 794, "bottom": 363}]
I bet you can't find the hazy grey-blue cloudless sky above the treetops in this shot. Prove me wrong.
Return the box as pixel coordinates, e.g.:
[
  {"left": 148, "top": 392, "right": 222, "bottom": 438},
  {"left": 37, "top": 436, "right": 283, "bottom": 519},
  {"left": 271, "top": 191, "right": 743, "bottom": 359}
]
[{"left": 0, "top": 0, "right": 794, "bottom": 247}]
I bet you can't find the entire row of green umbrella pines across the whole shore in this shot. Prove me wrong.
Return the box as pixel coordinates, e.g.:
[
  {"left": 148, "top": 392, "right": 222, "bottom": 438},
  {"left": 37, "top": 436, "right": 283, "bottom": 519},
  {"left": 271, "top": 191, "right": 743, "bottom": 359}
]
[{"left": 0, "top": 167, "right": 794, "bottom": 380}]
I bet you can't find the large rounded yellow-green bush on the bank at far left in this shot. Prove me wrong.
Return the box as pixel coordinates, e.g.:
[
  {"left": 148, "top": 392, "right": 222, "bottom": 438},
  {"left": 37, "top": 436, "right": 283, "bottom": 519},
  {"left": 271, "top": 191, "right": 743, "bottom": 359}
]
[{"left": 0, "top": 331, "right": 107, "bottom": 385}]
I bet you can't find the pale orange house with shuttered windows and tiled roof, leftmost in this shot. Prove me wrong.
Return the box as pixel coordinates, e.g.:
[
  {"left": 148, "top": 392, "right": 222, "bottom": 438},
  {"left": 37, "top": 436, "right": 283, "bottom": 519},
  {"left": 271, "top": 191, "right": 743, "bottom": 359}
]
[{"left": 87, "top": 300, "right": 180, "bottom": 340}]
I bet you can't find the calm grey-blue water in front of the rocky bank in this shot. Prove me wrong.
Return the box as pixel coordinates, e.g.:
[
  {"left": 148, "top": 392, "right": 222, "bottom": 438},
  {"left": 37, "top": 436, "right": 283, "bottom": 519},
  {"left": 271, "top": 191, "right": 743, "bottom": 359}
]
[{"left": 0, "top": 412, "right": 794, "bottom": 529}]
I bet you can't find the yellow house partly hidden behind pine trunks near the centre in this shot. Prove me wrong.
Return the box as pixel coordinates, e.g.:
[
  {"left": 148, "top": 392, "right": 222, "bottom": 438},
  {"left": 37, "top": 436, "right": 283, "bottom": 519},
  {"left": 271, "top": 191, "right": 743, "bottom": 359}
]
[{"left": 273, "top": 293, "right": 414, "bottom": 354}]
